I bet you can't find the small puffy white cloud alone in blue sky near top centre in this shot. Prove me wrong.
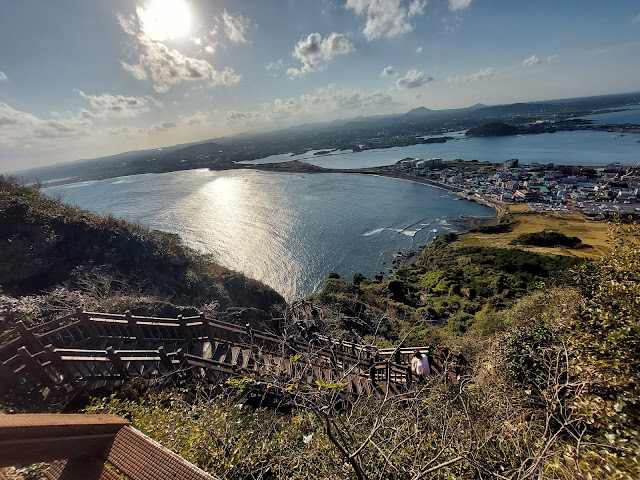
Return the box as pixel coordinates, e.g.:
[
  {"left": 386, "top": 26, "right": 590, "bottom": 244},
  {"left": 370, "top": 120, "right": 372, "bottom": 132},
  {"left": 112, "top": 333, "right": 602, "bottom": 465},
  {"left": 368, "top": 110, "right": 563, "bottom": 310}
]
[{"left": 287, "top": 32, "right": 353, "bottom": 76}]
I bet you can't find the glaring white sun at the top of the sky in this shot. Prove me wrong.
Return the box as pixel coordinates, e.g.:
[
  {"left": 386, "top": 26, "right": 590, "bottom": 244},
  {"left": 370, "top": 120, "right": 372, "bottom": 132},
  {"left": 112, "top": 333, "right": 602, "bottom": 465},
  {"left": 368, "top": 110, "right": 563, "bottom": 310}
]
[{"left": 138, "top": 0, "right": 191, "bottom": 40}]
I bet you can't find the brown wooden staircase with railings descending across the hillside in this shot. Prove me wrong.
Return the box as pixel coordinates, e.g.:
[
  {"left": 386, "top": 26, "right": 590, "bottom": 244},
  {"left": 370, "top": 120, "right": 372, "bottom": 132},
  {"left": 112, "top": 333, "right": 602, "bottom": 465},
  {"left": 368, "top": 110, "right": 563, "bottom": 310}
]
[{"left": 0, "top": 309, "right": 424, "bottom": 396}]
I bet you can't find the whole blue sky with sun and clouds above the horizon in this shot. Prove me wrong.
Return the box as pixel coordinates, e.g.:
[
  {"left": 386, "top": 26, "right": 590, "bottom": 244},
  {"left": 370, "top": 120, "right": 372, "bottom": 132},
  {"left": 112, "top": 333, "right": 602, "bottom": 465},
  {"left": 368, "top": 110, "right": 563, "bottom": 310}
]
[{"left": 0, "top": 0, "right": 640, "bottom": 172}]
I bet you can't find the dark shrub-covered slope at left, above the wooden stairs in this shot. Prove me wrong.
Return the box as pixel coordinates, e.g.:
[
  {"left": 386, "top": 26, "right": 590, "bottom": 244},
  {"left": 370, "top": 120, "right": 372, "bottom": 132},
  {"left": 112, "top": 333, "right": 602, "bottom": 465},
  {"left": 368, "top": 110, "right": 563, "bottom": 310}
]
[{"left": 0, "top": 176, "right": 284, "bottom": 324}]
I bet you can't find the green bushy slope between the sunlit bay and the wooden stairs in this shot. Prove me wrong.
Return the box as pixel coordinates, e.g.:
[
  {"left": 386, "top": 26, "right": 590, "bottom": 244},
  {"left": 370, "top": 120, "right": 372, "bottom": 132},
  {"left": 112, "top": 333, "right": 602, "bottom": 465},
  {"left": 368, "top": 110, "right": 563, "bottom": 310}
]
[{"left": 312, "top": 234, "right": 581, "bottom": 345}]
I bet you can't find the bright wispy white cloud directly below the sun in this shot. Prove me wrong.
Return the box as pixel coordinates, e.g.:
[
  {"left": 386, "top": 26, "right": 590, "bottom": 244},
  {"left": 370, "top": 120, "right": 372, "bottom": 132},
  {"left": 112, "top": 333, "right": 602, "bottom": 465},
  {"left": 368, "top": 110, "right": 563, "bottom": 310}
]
[{"left": 117, "top": 9, "right": 241, "bottom": 93}]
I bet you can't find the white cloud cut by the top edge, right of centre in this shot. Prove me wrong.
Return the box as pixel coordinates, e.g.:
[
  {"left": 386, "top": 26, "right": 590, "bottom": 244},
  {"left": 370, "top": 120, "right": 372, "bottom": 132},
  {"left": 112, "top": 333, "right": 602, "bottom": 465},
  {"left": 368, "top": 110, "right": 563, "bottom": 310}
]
[{"left": 346, "top": 0, "right": 426, "bottom": 40}]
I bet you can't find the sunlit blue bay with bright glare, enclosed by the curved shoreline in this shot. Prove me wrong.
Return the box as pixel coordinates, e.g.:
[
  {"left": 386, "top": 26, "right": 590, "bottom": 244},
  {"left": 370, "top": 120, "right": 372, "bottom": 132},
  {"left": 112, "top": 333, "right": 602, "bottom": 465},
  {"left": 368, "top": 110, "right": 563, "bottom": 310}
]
[{"left": 45, "top": 170, "right": 494, "bottom": 300}]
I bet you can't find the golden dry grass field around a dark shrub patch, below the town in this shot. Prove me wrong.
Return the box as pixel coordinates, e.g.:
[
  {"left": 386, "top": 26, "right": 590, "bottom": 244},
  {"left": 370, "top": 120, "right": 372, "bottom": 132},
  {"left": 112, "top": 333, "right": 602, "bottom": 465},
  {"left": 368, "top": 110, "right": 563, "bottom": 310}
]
[{"left": 459, "top": 205, "right": 611, "bottom": 258}]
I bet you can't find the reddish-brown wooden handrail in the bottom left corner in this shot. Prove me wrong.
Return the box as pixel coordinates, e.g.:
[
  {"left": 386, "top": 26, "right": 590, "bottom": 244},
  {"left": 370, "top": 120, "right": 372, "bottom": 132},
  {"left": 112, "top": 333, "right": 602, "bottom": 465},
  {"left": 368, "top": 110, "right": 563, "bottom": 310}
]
[{"left": 0, "top": 414, "right": 214, "bottom": 480}]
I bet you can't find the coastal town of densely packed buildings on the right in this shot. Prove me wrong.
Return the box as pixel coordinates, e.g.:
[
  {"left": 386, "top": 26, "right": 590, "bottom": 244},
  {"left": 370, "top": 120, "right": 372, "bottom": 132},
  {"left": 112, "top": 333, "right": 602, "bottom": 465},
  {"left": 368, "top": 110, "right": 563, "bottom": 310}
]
[{"left": 380, "top": 158, "right": 640, "bottom": 218}]
